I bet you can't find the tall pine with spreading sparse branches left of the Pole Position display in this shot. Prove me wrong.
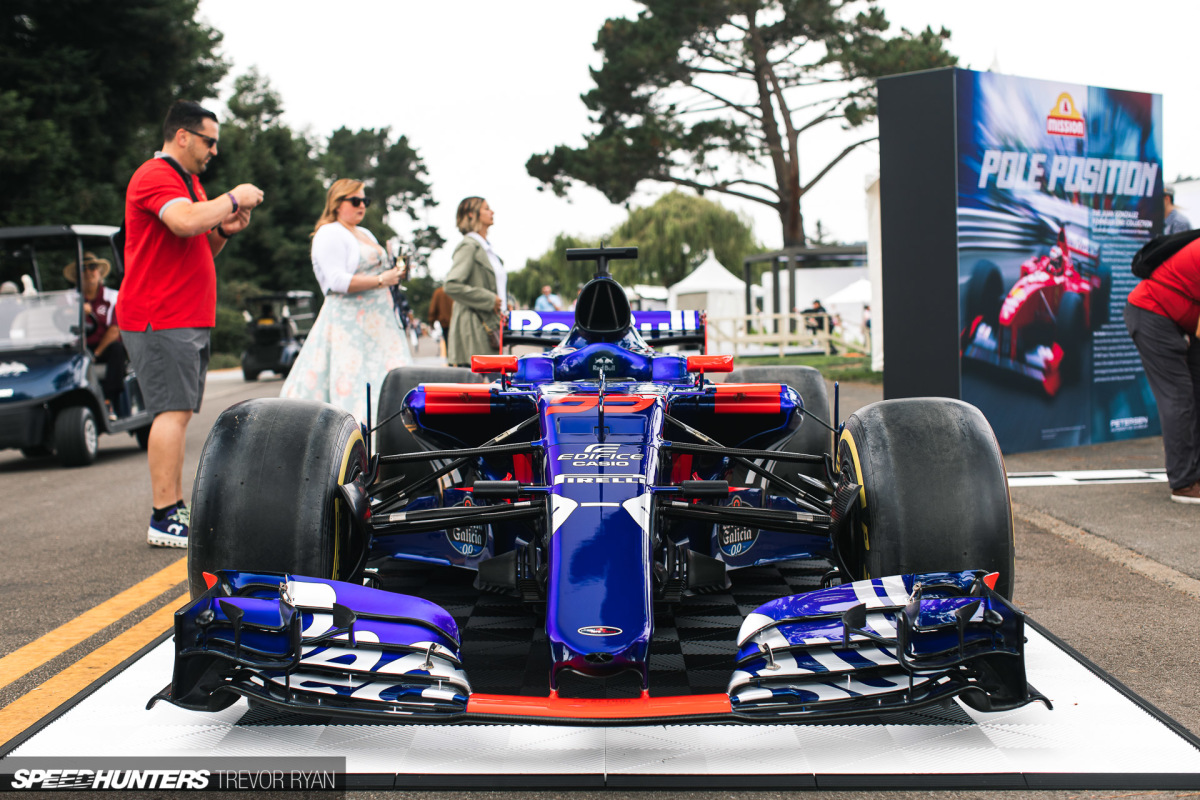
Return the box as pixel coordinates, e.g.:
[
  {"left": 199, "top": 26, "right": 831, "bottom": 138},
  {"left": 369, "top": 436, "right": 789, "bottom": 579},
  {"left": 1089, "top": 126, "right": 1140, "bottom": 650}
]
[{"left": 526, "top": 0, "right": 956, "bottom": 246}]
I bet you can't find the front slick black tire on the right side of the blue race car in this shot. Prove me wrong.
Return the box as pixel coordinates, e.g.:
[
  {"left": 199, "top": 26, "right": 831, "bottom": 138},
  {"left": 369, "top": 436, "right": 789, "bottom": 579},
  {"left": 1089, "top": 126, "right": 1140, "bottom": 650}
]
[{"left": 838, "top": 397, "right": 1014, "bottom": 599}]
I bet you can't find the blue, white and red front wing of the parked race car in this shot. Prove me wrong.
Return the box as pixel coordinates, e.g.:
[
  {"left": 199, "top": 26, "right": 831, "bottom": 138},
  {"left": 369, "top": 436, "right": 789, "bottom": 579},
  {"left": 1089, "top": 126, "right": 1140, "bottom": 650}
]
[{"left": 150, "top": 571, "right": 1049, "bottom": 726}]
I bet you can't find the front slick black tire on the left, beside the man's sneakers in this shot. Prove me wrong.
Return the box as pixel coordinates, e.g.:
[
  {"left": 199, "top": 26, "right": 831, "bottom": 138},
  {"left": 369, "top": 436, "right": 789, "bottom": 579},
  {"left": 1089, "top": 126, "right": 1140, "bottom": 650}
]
[{"left": 187, "top": 398, "right": 367, "bottom": 597}]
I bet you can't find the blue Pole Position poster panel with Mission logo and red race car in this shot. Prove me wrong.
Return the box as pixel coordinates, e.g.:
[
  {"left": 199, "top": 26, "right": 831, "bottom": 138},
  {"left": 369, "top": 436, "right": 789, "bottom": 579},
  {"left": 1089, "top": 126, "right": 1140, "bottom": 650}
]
[{"left": 955, "top": 71, "right": 1163, "bottom": 452}]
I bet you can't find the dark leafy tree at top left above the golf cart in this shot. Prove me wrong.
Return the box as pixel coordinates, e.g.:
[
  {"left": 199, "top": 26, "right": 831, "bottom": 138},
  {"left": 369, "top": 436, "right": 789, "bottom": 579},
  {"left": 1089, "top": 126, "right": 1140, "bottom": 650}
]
[{"left": 0, "top": 0, "right": 227, "bottom": 225}]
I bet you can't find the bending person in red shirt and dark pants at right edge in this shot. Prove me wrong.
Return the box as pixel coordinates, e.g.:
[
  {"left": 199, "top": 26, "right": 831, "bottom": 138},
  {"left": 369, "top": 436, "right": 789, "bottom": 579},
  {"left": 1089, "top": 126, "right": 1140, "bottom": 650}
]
[{"left": 1124, "top": 240, "right": 1200, "bottom": 503}]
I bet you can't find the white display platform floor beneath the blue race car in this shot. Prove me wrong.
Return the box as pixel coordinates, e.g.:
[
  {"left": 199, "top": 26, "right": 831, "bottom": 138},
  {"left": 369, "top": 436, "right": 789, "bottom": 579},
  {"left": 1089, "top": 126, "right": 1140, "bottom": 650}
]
[{"left": 0, "top": 625, "right": 1200, "bottom": 789}]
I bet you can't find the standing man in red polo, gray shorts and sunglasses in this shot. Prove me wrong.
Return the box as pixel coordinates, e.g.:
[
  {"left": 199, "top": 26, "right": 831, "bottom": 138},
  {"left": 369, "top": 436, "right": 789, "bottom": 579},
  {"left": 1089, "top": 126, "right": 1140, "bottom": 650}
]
[{"left": 116, "top": 101, "right": 263, "bottom": 547}]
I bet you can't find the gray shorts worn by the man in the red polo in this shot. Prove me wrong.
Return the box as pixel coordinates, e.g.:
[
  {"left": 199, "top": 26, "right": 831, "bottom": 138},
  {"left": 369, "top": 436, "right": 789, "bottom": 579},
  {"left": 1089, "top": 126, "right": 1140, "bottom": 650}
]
[{"left": 121, "top": 326, "right": 211, "bottom": 415}]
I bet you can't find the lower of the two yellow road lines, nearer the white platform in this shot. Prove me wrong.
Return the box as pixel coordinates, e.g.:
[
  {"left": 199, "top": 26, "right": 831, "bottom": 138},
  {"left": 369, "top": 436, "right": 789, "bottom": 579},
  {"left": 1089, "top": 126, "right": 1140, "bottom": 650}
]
[{"left": 0, "top": 587, "right": 191, "bottom": 750}]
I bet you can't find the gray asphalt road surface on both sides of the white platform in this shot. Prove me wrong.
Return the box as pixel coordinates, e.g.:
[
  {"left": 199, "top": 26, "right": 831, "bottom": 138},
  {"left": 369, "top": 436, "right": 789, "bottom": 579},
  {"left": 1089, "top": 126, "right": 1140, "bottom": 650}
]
[{"left": 0, "top": 373, "right": 1200, "bottom": 800}]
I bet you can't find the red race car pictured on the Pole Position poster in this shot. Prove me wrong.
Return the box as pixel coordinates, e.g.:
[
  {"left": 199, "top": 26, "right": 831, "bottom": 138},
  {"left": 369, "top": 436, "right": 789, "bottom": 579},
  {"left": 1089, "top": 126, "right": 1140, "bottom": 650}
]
[{"left": 962, "top": 225, "right": 1112, "bottom": 397}]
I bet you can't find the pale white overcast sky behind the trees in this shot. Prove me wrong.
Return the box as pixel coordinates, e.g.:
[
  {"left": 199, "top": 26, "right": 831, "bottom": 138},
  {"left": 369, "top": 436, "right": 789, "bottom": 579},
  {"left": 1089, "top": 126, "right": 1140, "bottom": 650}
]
[{"left": 199, "top": 0, "right": 1200, "bottom": 272}]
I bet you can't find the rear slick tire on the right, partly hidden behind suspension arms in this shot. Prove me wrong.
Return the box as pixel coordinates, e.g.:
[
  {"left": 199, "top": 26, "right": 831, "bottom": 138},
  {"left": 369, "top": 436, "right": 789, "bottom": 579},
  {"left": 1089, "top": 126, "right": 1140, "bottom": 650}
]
[{"left": 726, "top": 366, "right": 833, "bottom": 486}]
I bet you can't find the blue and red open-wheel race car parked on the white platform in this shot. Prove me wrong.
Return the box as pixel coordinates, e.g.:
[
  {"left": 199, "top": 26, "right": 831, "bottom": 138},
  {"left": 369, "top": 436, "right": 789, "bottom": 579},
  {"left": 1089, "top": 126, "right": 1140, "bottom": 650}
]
[{"left": 155, "top": 248, "right": 1045, "bottom": 724}]
